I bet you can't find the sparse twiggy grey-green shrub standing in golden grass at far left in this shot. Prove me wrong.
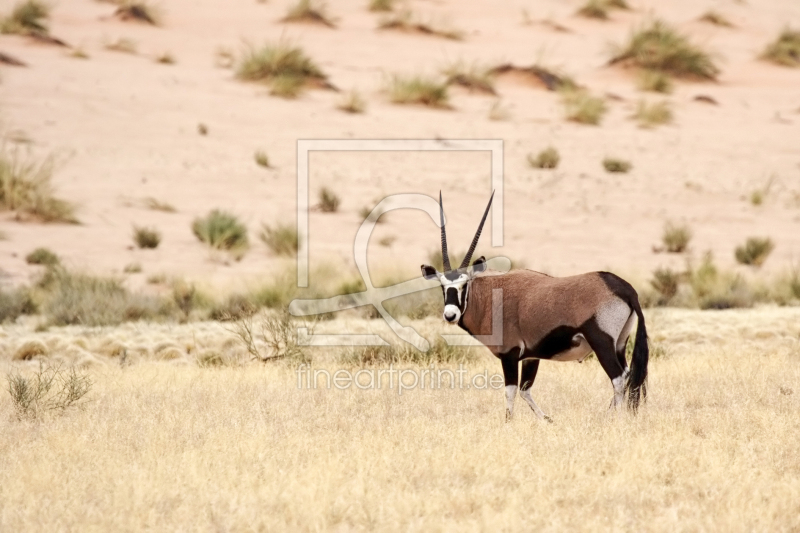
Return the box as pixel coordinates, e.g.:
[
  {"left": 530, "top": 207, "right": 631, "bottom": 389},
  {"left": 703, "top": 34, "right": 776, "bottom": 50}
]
[{"left": 6, "top": 365, "right": 92, "bottom": 420}]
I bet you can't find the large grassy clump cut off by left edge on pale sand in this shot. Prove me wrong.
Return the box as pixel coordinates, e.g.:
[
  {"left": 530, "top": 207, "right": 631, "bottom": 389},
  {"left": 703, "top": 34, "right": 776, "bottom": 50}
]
[{"left": 0, "top": 146, "right": 77, "bottom": 223}]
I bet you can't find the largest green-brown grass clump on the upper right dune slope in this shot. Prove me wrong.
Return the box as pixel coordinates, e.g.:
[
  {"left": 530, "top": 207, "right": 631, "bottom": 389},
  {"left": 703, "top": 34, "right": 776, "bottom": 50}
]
[{"left": 611, "top": 19, "right": 719, "bottom": 80}]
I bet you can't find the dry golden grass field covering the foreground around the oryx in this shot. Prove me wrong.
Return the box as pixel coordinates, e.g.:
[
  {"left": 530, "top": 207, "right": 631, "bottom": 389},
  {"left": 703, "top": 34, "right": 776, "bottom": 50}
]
[{"left": 0, "top": 308, "right": 800, "bottom": 531}]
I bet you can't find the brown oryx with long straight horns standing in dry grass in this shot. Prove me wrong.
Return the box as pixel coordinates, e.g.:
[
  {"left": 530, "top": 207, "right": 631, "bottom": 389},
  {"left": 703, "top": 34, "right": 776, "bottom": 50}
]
[{"left": 422, "top": 193, "right": 648, "bottom": 421}]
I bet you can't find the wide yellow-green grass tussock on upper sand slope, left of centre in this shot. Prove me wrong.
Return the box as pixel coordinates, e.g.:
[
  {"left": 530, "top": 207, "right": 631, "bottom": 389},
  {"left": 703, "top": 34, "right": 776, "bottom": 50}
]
[{"left": 236, "top": 41, "right": 330, "bottom": 98}]
